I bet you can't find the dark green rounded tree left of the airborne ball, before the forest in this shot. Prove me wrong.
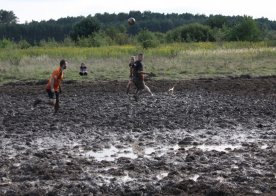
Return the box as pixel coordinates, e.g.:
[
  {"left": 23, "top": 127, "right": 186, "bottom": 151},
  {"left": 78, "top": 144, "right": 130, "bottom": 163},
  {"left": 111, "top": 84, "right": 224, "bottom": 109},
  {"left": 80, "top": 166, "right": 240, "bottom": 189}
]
[{"left": 71, "top": 16, "right": 100, "bottom": 41}]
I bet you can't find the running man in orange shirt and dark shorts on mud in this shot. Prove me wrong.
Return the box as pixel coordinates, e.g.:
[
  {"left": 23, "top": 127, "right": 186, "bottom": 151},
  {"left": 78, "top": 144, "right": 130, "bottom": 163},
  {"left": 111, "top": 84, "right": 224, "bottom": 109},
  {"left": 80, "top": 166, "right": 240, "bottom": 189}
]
[{"left": 33, "top": 59, "right": 67, "bottom": 112}]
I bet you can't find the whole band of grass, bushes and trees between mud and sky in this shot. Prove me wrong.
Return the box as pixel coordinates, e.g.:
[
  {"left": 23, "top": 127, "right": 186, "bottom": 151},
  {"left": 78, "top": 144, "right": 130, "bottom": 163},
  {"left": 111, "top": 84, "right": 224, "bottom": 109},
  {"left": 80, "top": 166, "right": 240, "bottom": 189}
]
[{"left": 0, "top": 10, "right": 276, "bottom": 83}]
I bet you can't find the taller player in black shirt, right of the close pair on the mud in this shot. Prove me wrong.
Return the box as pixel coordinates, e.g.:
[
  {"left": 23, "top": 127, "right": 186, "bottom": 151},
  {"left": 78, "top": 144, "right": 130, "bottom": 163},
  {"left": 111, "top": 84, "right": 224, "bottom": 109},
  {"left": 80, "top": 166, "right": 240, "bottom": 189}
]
[{"left": 133, "top": 53, "right": 153, "bottom": 101}]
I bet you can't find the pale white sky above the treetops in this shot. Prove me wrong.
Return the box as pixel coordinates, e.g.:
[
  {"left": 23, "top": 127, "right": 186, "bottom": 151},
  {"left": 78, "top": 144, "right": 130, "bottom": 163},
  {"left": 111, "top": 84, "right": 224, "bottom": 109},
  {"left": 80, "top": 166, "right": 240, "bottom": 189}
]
[{"left": 0, "top": 0, "right": 276, "bottom": 23}]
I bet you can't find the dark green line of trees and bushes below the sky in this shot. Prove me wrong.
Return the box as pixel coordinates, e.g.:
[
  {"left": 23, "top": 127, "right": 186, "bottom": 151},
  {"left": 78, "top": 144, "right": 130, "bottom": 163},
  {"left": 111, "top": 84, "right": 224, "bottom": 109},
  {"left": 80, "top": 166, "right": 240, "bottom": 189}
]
[{"left": 0, "top": 10, "right": 276, "bottom": 48}]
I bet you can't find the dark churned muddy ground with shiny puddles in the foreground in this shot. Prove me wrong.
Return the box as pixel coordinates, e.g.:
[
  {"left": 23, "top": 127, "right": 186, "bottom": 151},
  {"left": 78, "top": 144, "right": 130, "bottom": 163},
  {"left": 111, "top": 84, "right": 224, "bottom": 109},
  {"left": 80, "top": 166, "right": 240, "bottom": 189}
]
[{"left": 0, "top": 77, "right": 276, "bottom": 195}]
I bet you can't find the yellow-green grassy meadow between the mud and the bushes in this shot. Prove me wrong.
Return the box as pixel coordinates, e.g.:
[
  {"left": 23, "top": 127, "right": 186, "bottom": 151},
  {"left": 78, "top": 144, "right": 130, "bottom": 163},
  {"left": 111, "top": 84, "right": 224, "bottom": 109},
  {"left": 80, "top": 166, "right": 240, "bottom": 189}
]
[{"left": 0, "top": 42, "right": 276, "bottom": 83}]
